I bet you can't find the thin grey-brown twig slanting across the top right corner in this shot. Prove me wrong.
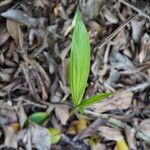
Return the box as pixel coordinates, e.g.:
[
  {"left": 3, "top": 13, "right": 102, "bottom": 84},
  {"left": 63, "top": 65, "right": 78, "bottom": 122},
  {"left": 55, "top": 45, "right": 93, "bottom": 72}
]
[{"left": 118, "top": 0, "right": 150, "bottom": 20}]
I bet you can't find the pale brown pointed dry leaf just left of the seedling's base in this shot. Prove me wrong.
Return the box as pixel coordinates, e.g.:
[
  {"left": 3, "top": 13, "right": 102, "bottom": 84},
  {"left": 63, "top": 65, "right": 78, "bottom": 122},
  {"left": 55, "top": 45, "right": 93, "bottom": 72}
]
[{"left": 55, "top": 106, "right": 69, "bottom": 125}]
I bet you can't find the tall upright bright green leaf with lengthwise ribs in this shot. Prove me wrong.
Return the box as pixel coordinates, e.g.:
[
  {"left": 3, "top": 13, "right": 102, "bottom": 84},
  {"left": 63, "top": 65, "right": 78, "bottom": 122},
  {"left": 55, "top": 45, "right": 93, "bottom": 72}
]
[{"left": 69, "top": 11, "right": 90, "bottom": 106}]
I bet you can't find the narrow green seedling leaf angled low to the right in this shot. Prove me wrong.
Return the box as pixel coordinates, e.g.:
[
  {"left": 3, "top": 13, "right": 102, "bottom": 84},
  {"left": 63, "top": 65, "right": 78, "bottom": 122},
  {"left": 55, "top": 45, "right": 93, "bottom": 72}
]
[{"left": 76, "top": 93, "right": 113, "bottom": 109}]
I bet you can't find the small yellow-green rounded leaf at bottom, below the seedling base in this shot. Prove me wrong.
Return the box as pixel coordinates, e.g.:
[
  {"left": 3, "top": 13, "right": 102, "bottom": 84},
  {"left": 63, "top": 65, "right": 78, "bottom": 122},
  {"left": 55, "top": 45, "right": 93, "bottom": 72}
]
[{"left": 49, "top": 128, "right": 62, "bottom": 144}]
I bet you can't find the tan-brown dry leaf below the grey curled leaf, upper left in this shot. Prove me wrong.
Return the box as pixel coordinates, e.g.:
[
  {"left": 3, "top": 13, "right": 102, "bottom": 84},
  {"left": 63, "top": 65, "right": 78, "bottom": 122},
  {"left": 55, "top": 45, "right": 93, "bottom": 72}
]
[{"left": 7, "top": 19, "right": 24, "bottom": 47}]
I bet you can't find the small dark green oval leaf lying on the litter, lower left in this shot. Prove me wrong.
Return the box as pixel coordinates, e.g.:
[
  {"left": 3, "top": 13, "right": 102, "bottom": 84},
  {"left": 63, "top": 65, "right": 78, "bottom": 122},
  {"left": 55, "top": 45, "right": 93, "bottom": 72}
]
[{"left": 29, "top": 112, "right": 49, "bottom": 125}]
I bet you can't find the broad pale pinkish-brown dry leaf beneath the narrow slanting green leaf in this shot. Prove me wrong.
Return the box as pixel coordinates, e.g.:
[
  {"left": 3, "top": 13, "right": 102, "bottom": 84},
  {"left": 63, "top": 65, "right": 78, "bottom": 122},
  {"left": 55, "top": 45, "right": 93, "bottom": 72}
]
[{"left": 90, "top": 92, "right": 133, "bottom": 113}]
